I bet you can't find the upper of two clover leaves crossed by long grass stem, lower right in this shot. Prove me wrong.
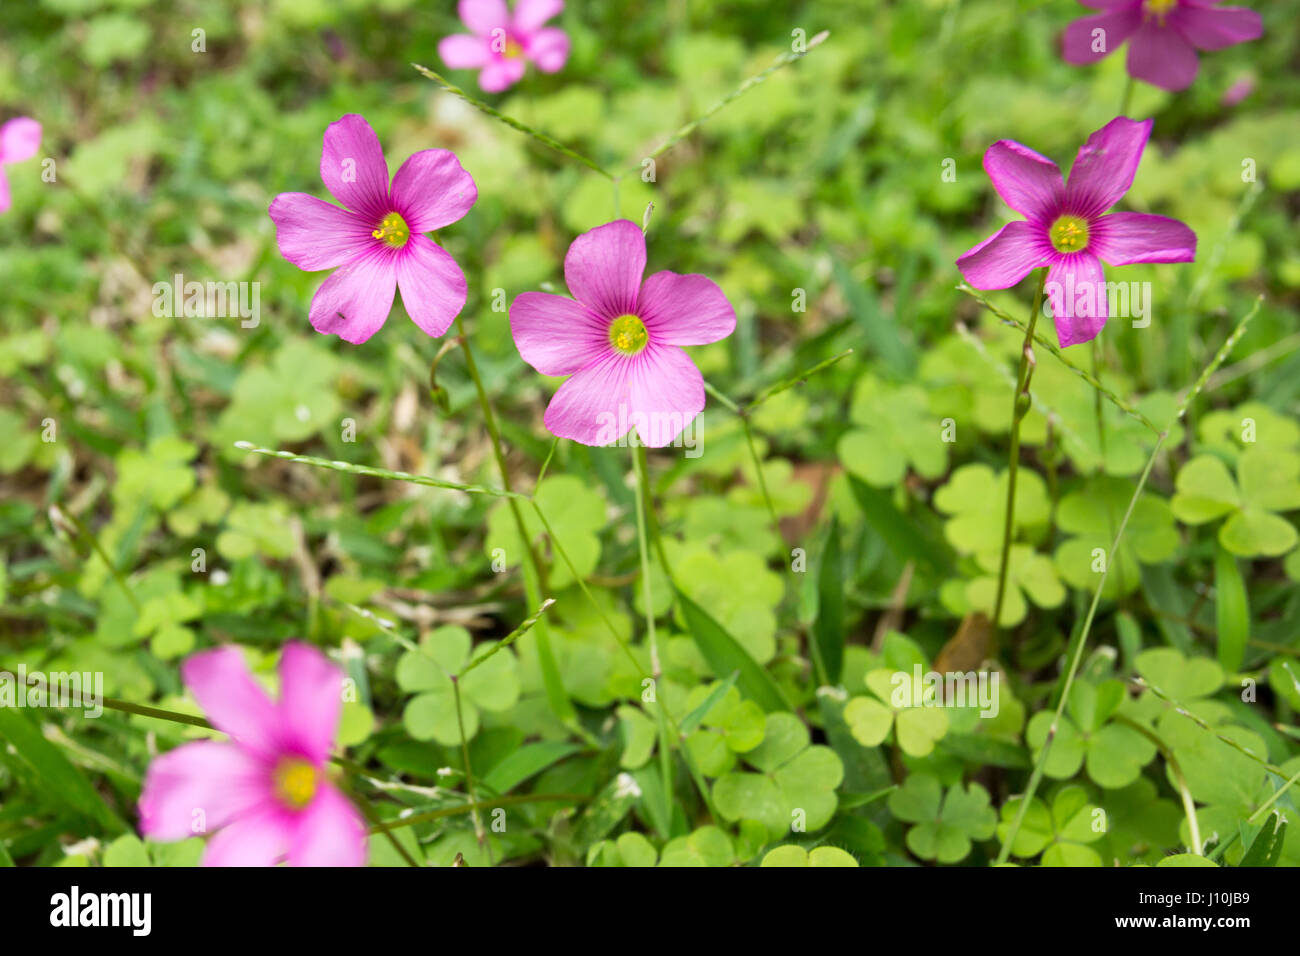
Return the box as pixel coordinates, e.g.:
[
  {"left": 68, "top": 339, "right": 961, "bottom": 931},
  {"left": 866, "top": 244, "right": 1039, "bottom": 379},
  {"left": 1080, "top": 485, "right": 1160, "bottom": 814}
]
[{"left": 1024, "top": 680, "right": 1156, "bottom": 790}]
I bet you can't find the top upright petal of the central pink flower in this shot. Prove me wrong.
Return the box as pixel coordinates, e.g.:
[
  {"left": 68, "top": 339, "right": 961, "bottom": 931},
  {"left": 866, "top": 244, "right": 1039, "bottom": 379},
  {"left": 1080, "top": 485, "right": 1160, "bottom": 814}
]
[{"left": 564, "top": 219, "right": 646, "bottom": 319}]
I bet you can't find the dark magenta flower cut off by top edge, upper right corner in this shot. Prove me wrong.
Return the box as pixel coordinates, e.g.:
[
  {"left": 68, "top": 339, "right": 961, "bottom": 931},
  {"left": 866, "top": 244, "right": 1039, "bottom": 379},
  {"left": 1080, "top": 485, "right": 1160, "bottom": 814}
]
[{"left": 1063, "top": 0, "right": 1264, "bottom": 90}]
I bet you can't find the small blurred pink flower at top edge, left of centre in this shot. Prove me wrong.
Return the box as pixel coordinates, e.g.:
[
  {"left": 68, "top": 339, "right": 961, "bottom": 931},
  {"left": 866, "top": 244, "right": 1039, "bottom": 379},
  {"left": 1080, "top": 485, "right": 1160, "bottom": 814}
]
[{"left": 438, "top": 0, "right": 568, "bottom": 92}]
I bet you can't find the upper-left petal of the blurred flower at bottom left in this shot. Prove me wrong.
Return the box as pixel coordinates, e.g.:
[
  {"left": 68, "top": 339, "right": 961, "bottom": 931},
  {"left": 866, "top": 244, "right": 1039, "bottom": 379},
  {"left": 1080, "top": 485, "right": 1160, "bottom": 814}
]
[{"left": 181, "top": 646, "right": 283, "bottom": 757}]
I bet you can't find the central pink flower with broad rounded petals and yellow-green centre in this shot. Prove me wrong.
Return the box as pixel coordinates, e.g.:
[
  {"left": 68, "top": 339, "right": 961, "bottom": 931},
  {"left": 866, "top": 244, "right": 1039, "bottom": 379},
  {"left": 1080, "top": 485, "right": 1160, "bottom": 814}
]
[{"left": 510, "top": 219, "right": 736, "bottom": 447}]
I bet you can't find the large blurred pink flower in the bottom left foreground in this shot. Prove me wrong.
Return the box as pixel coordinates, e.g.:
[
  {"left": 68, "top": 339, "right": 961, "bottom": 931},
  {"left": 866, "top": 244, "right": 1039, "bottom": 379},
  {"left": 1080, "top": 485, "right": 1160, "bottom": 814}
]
[{"left": 139, "top": 643, "right": 365, "bottom": 866}]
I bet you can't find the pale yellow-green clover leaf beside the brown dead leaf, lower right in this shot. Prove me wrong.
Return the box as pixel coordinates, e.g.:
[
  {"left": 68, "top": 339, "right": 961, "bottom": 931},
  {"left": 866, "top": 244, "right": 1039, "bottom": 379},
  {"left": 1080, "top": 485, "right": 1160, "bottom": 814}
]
[{"left": 844, "top": 669, "right": 948, "bottom": 757}]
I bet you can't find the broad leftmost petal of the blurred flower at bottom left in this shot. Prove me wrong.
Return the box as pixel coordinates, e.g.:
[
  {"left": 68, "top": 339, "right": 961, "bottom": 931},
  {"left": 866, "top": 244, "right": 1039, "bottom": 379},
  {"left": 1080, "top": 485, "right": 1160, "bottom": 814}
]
[{"left": 139, "top": 740, "right": 272, "bottom": 840}]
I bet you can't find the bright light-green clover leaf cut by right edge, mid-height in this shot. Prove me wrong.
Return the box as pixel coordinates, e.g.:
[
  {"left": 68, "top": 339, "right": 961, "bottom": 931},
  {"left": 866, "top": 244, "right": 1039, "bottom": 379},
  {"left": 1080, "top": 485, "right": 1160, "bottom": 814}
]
[{"left": 1170, "top": 447, "right": 1300, "bottom": 558}]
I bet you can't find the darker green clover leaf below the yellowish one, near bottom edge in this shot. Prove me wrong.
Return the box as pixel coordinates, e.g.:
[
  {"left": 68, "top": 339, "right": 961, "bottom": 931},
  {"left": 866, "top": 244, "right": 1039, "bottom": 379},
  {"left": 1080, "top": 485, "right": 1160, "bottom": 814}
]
[{"left": 889, "top": 773, "right": 997, "bottom": 864}]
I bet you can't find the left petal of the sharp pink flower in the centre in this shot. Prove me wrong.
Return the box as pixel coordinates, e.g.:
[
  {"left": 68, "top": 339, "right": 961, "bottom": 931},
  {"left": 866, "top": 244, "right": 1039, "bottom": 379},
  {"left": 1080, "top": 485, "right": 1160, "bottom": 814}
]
[{"left": 510, "top": 293, "right": 610, "bottom": 375}]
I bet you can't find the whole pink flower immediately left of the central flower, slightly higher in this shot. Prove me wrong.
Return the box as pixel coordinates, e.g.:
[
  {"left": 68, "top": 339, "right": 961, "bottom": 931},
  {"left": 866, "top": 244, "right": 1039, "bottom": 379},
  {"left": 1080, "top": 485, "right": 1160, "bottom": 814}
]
[{"left": 269, "top": 113, "right": 478, "bottom": 345}]
